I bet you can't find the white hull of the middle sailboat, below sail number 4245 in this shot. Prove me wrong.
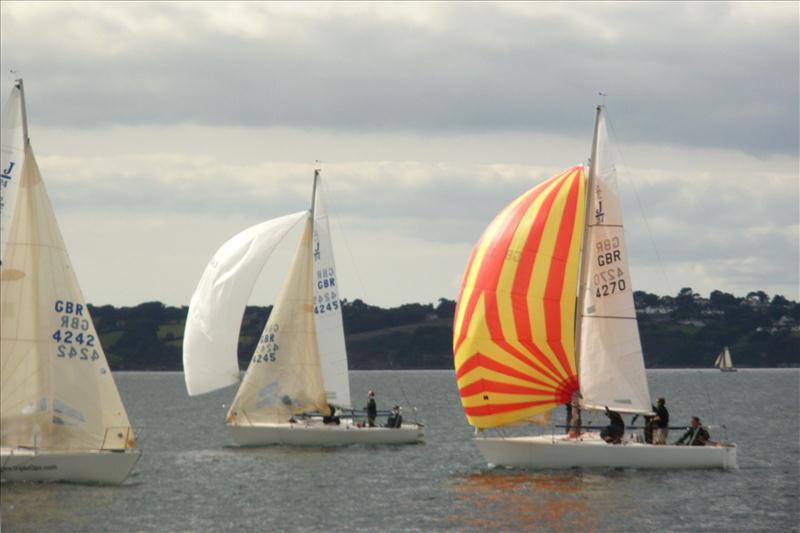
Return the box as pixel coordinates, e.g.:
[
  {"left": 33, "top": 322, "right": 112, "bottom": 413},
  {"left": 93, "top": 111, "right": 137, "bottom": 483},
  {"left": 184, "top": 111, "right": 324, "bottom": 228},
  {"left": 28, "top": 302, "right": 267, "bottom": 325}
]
[{"left": 226, "top": 420, "right": 425, "bottom": 446}]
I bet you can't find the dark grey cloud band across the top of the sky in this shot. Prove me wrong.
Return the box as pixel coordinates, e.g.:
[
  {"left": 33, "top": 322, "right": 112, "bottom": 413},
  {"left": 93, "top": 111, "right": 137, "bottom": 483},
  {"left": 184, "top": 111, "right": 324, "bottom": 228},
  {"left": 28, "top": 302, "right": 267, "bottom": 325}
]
[{"left": 2, "top": 3, "right": 800, "bottom": 154}]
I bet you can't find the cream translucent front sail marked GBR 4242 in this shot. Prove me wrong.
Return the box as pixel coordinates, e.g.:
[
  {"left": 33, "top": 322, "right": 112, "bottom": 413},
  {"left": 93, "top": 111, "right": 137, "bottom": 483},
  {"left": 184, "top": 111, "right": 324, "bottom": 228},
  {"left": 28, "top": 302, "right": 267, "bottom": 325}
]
[{"left": 0, "top": 145, "right": 133, "bottom": 450}]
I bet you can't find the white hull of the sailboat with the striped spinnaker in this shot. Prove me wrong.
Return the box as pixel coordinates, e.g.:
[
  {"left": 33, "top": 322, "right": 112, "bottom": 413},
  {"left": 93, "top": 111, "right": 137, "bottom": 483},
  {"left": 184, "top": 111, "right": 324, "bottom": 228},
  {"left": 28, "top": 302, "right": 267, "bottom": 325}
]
[{"left": 475, "top": 433, "right": 739, "bottom": 469}]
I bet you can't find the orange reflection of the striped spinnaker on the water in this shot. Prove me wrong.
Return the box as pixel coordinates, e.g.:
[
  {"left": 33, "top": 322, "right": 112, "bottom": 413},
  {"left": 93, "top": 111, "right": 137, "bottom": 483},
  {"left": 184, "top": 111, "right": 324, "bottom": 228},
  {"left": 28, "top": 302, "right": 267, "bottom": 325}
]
[{"left": 450, "top": 471, "right": 596, "bottom": 531}]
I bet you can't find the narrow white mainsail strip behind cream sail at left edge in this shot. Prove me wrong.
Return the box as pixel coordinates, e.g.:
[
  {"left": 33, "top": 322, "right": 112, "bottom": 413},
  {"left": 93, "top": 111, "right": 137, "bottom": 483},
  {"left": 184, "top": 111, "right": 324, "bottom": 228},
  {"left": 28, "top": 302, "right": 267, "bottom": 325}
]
[{"left": 0, "top": 81, "right": 25, "bottom": 268}]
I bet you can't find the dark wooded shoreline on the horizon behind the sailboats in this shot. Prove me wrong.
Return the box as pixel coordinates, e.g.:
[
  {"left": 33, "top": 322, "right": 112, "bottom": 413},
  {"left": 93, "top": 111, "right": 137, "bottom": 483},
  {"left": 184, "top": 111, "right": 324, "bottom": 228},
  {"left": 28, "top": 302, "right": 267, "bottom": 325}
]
[{"left": 89, "top": 287, "right": 800, "bottom": 370}]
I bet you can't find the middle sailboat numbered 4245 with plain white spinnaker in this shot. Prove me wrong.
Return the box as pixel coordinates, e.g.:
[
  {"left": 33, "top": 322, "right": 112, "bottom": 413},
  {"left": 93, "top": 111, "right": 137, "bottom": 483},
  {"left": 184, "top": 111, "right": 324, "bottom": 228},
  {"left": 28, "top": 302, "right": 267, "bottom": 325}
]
[{"left": 183, "top": 169, "right": 424, "bottom": 446}]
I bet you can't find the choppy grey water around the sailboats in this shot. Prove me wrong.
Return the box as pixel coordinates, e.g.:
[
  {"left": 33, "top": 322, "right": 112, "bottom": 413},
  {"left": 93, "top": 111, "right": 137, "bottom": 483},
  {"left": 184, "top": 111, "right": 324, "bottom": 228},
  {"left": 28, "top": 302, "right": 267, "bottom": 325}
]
[{"left": 0, "top": 370, "right": 800, "bottom": 532}]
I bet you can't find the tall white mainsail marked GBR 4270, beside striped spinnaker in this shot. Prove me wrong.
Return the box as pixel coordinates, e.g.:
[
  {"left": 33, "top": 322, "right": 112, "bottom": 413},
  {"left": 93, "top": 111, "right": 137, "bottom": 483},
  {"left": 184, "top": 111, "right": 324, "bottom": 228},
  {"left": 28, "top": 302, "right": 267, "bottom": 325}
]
[{"left": 578, "top": 109, "right": 652, "bottom": 413}]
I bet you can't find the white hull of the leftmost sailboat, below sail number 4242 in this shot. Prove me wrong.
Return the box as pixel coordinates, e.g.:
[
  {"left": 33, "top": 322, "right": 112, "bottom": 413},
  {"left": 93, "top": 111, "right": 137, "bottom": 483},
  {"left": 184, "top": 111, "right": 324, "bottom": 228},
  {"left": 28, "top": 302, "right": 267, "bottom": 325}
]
[{"left": 0, "top": 447, "right": 141, "bottom": 484}]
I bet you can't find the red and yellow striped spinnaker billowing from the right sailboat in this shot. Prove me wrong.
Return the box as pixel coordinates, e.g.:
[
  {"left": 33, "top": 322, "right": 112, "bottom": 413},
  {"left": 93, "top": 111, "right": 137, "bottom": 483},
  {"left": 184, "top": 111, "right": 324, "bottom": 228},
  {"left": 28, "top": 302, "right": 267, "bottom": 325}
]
[{"left": 453, "top": 166, "right": 585, "bottom": 428}]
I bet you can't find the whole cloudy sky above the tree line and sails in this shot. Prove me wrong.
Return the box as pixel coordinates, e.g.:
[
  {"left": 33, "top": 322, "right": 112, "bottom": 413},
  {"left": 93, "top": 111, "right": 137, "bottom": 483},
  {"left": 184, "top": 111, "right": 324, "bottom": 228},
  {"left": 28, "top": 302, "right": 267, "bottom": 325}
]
[{"left": 0, "top": 2, "right": 800, "bottom": 306}]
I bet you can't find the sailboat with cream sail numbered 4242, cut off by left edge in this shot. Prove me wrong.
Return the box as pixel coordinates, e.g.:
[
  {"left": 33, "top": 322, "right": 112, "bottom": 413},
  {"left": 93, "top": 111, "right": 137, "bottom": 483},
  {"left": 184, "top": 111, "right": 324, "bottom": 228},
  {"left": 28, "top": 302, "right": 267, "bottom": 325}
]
[{"left": 0, "top": 79, "right": 140, "bottom": 483}]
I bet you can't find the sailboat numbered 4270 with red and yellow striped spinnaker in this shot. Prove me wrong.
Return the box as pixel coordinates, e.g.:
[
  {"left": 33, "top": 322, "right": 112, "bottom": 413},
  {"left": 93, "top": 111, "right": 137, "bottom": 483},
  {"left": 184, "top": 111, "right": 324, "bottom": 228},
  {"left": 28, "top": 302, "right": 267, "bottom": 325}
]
[{"left": 453, "top": 106, "right": 736, "bottom": 468}]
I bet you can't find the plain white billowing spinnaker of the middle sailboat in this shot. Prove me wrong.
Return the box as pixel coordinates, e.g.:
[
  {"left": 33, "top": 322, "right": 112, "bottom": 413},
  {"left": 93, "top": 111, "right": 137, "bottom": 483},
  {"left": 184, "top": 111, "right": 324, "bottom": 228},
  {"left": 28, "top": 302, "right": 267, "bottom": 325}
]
[{"left": 183, "top": 211, "right": 309, "bottom": 396}]
